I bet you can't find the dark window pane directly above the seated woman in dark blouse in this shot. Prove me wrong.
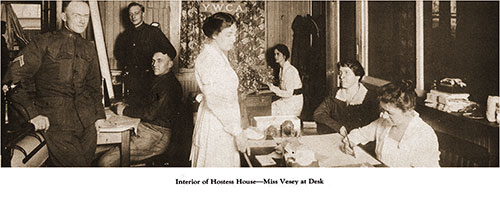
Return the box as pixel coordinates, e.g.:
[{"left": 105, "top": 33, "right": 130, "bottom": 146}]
[{"left": 368, "top": 1, "right": 416, "bottom": 82}]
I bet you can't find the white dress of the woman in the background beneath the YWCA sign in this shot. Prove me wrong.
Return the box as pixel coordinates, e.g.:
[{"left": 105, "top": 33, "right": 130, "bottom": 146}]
[{"left": 271, "top": 61, "right": 304, "bottom": 116}]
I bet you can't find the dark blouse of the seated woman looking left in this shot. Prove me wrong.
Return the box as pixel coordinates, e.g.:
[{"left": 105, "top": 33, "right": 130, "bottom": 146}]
[{"left": 314, "top": 85, "right": 379, "bottom": 134}]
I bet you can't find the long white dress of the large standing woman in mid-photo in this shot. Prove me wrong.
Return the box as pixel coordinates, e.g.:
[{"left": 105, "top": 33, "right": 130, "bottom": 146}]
[{"left": 190, "top": 45, "right": 242, "bottom": 167}]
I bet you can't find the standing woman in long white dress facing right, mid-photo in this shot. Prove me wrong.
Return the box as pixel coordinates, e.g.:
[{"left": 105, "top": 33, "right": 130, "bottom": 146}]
[{"left": 190, "top": 12, "right": 247, "bottom": 167}]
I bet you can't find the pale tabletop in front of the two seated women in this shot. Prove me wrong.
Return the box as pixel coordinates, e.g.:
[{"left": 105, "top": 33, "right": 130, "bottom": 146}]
[{"left": 249, "top": 133, "right": 381, "bottom": 167}]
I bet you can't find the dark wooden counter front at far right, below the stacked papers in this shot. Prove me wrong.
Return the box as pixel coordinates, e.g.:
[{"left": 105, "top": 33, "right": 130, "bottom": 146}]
[{"left": 416, "top": 103, "right": 499, "bottom": 167}]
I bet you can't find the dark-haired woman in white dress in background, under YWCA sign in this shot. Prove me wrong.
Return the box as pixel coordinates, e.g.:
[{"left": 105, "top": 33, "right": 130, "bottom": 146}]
[{"left": 267, "top": 44, "right": 304, "bottom": 116}]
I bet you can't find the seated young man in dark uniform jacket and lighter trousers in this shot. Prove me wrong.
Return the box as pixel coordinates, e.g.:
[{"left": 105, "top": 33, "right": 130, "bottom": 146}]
[{"left": 98, "top": 49, "right": 182, "bottom": 166}]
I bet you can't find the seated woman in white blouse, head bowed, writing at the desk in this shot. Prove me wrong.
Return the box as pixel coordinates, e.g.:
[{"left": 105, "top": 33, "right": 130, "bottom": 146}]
[{"left": 342, "top": 81, "right": 440, "bottom": 167}]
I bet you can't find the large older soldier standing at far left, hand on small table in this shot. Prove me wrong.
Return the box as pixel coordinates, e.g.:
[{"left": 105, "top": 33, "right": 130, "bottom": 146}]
[{"left": 1, "top": 1, "right": 105, "bottom": 166}]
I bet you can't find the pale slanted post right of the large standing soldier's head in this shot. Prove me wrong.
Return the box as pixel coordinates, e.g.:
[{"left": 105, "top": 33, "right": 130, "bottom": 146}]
[{"left": 89, "top": 0, "right": 115, "bottom": 99}]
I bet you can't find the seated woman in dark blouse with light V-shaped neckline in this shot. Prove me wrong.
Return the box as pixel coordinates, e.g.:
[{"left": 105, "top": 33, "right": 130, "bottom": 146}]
[{"left": 314, "top": 60, "right": 378, "bottom": 134}]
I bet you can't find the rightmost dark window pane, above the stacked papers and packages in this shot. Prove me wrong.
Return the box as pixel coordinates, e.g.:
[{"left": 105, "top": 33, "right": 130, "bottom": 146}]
[{"left": 424, "top": 1, "right": 499, "bottom": 103}]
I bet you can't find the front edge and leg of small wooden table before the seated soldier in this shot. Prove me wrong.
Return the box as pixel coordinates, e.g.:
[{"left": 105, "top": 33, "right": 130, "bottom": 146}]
[{"left": 97, "top": 128, "right": 134, "bottom": 166}]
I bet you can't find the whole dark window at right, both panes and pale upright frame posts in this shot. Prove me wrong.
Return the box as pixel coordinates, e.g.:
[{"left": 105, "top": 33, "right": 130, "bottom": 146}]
[{"left": 356, "top": 0, "right": 499, "bottom": 103}]
